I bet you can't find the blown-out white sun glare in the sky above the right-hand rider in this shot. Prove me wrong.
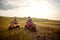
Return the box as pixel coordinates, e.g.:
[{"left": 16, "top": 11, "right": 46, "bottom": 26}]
[{"left": 24, "top": 1, "right": 48, "bottom": 18}]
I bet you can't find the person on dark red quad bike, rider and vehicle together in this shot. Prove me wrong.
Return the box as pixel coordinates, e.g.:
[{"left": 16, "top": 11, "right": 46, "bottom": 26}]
[{"left": 25, "top": 17, "right": 36, "bottom": 32}]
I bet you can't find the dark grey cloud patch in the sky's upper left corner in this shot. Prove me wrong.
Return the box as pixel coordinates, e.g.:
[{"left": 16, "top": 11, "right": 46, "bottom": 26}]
[{"left": 0, "top": 0, "right": 16, "bottom": 10}]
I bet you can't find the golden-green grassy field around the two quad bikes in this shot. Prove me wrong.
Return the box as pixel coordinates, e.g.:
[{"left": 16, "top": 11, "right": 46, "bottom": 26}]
[{"left": 0, "top": 17, "right": 60, "bottom": 40}]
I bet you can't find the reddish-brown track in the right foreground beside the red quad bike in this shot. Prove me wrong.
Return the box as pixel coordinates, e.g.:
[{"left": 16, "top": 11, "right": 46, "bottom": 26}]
[{"left": 32, "top": 25, "right": 57, "bottom": 40}]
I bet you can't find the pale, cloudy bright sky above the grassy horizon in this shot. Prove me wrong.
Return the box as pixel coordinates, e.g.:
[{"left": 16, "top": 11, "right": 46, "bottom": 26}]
[{"left": 0, "top": 0, "right": 60, "bottom": 20}]
